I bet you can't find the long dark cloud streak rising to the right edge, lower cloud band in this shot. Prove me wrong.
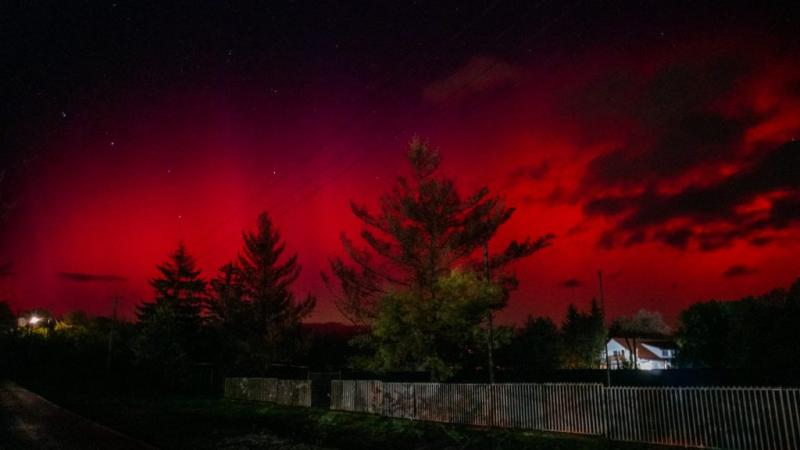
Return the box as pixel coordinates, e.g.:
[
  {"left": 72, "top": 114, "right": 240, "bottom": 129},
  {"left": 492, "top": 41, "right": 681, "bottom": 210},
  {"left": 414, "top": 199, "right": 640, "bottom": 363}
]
[{"left": 583, "top": 142, "right": 800, "bottom": 250}]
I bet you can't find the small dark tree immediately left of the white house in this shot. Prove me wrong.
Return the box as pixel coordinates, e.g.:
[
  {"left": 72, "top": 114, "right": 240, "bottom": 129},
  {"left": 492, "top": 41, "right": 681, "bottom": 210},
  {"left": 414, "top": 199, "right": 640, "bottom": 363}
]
[{"left": 561, "top": 299, "right": 608, "bottom": 369}]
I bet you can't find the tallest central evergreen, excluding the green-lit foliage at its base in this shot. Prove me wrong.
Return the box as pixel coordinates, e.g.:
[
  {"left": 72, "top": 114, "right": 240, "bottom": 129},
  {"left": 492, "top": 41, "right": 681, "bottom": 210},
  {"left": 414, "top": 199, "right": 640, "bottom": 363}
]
[{"left": 323, "top": 138, "right": 553, "bottom": 373}]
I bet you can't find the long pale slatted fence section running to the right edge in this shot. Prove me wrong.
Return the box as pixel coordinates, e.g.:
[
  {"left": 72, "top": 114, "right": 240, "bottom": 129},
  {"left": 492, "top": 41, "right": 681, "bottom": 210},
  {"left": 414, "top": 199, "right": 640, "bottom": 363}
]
[{"left": 331, "top": 380, "right": 800, "bottom": 450}]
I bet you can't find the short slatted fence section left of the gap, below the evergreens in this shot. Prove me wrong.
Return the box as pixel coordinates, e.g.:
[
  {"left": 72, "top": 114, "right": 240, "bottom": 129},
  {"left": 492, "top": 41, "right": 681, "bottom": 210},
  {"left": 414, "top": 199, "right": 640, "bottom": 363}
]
[{"left": 224, "top": 378, "right": 311, "bottom": 406}]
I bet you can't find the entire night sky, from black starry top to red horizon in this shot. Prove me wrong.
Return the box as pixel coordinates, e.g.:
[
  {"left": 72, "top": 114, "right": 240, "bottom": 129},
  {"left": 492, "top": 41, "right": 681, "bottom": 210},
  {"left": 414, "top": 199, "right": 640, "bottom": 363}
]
[{"left": 0, "top": 0, "right": 800, "bottom": 322}]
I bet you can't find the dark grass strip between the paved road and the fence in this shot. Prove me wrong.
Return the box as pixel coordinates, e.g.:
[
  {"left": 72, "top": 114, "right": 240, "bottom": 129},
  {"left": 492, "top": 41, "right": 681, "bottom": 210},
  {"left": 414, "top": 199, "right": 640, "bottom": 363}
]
[{"left": 55, "top": 397, "right": 665, "bottom": 450}]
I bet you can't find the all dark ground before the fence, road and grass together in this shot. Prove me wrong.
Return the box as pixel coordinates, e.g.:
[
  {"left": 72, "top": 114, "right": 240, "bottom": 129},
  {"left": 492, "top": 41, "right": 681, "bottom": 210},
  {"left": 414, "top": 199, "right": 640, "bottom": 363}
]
[{"left": 0, "top": 384, "right": 676, "bottom": 450}]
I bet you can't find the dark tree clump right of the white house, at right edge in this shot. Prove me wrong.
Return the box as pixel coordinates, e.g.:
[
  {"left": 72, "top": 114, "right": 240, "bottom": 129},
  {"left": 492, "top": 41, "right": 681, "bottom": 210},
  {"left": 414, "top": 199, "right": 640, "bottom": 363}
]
[{"left": 677, "top": 279, "right": 800, "bottom": 370}]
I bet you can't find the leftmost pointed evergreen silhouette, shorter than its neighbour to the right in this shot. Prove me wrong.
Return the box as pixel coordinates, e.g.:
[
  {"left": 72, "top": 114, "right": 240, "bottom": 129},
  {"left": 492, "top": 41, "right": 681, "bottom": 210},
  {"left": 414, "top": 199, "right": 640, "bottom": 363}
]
[{"left": 134, "top": 243, "right": 206, "bottom": 383}]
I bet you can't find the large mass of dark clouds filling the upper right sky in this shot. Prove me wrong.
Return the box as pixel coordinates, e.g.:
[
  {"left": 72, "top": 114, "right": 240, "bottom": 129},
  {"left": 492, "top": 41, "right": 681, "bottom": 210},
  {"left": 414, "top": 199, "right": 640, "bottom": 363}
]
[{"left": 567, "top": 51, "right": 800, "bottom": 251}]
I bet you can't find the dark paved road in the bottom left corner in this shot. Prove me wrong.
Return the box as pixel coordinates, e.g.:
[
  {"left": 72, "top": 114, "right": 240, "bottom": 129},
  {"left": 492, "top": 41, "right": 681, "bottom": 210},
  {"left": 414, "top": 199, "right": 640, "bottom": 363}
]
[{"left": 0, "top": 381, "right": 153, "bottom": 450}]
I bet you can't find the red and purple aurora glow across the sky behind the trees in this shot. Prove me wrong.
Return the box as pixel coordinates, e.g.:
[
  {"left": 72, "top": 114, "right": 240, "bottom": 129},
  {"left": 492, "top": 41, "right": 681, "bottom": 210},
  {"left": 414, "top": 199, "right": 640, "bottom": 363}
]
[{"left": 0, "top": 3, "right": 800, "bottom": 322}]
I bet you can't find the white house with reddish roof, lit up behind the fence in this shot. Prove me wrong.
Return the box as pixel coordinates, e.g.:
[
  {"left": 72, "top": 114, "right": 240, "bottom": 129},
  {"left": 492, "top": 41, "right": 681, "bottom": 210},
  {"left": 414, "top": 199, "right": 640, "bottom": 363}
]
[{"left": 606, "top": 338, "right": 677, "bottom": 370}]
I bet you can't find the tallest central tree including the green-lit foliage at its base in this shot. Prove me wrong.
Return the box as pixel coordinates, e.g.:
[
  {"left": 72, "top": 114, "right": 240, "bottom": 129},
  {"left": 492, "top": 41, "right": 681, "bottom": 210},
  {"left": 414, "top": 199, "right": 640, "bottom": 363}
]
[{"left": 323, "top": 138, "right": 553, "bottom": 377}]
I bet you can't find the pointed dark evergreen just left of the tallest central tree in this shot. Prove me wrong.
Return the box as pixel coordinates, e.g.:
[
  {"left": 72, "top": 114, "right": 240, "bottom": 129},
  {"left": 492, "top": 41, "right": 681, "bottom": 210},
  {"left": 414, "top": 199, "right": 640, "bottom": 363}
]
[{"left": 239, "top": 213, "right": 316, "bottom": 365}]
